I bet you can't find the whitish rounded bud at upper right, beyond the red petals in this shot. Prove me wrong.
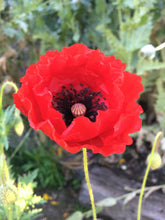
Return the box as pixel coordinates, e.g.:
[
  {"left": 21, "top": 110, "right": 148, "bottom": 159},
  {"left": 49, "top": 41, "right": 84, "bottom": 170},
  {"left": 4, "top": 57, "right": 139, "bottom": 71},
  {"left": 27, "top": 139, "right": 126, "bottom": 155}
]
[{"left": 139, "top": 44, "right": 156, "bottom": 60}]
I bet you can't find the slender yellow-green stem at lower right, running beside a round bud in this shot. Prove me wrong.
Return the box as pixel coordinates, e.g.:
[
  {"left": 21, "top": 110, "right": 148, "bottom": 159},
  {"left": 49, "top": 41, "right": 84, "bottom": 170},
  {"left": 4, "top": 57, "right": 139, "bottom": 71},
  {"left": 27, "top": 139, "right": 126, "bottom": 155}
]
[{"left": 137, "top": 132, "right": 162, "bottom": 220}]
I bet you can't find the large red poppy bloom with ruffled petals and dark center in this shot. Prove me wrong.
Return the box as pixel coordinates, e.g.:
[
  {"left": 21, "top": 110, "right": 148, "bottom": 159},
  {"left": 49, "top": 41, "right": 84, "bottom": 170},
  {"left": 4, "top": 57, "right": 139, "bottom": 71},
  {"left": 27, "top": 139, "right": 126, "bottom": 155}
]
[{"left": 14, "top": 44, "right": 143, "bottom": 156}]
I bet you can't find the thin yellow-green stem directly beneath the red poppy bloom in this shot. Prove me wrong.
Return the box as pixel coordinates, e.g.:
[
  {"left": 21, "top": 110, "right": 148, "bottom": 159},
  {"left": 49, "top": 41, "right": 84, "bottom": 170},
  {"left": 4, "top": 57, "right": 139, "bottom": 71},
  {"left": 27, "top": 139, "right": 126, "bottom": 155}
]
[{"left": 83, "top": 148, "right": 97, "bottom": 220}]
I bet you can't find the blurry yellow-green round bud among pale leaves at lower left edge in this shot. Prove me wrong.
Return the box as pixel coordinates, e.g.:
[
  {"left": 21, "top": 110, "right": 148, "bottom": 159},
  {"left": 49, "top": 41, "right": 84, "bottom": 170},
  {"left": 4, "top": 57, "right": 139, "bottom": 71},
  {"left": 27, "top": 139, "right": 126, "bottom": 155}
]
[{"left": 0, "top": 184, "right": 17, "bottom": 204}]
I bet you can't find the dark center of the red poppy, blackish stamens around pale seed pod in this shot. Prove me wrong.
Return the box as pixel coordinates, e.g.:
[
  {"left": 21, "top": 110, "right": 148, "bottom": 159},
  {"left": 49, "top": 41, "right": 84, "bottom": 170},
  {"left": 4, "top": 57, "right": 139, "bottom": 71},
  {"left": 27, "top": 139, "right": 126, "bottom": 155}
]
[{"left": 52, "top": 83, "right": 107, "bottom": 127}]
